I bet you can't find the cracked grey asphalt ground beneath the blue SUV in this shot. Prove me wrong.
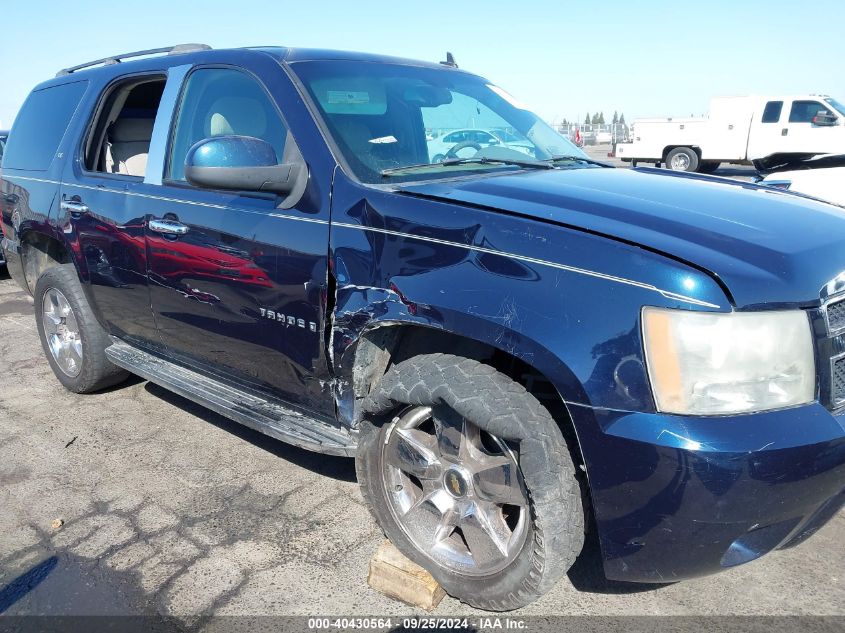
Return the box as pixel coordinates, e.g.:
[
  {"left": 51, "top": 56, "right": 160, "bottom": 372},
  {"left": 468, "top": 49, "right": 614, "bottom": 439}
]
[{"left": 0, "top": 273, "right": 845, "bottom": 630}]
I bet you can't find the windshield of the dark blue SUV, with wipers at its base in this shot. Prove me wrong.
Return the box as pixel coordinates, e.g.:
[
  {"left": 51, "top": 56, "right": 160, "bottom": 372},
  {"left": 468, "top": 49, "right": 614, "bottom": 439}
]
[{"left": 291, "top": 60, "right": 586, "bottom": 183}]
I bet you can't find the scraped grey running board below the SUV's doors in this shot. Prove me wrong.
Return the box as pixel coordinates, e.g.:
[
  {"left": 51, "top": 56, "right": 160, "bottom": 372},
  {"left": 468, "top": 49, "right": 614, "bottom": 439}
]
[{"left": 106, "top": 341, "right": 356, "bottom": 457}]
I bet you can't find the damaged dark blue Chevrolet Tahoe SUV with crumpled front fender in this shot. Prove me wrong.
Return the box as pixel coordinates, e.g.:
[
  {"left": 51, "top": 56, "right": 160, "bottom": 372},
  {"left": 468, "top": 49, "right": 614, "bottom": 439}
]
[{"left": 0, "top": 45, "right": 845, "bottom": 610}]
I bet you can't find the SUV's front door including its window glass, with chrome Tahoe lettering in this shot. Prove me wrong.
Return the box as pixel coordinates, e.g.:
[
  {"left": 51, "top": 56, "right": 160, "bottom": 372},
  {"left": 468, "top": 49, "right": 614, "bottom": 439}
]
[{"left": 140, "top": 65, "right": 334, "bottom": 415}]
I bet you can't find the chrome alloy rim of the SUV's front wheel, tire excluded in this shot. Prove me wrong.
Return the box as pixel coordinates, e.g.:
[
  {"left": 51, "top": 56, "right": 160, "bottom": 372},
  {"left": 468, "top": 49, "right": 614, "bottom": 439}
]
[{"left": 382, "top": 407, "right": 530, "bottom": 576}]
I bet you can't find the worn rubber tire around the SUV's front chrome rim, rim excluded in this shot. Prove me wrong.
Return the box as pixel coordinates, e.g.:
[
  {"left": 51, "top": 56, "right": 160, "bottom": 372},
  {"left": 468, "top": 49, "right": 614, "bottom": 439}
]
[{"left": 355, "top": 354, "right": 584, "bottom": 611}]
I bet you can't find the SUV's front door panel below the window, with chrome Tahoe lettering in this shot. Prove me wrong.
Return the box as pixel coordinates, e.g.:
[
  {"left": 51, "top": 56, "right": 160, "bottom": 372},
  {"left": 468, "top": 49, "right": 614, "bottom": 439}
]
[{"left": 136, "top": 185, "right": 330, "bottom": 410}]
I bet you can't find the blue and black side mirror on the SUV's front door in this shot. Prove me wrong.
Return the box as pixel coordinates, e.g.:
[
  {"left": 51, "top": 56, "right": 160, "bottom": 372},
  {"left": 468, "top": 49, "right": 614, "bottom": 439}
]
[{"left": 185, "top": 135, "right": 302, "bottom": 194}]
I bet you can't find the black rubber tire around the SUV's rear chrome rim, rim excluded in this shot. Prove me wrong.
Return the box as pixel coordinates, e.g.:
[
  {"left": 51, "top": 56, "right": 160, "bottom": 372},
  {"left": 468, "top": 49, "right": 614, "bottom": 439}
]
[{"left": 34, "top": 264, "right": 129, "bottom": 393}]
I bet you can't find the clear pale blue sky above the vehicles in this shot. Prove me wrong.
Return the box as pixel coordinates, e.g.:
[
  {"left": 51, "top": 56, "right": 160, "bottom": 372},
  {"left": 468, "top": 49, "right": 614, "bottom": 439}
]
[{"left": 0, "top": 0, "right": 845, "bottom": 127}]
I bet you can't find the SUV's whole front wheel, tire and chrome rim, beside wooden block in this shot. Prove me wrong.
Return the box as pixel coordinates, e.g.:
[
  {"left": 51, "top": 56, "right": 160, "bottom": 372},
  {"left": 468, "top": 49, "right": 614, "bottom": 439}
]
[{"left": 356, "top": 354, "right": 584, "bottom": 611}]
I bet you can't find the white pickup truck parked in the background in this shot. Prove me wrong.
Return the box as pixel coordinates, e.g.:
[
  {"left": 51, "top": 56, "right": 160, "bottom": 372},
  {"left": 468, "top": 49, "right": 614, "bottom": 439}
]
[{"left": 616, "top": 95, "right": 845, "bottom": 173}]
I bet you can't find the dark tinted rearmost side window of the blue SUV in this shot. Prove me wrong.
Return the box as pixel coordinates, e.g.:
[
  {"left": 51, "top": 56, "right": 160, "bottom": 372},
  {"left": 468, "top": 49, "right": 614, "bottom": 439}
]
[{"left": 3, "top": 81, "right": 88, "bottom": 171}]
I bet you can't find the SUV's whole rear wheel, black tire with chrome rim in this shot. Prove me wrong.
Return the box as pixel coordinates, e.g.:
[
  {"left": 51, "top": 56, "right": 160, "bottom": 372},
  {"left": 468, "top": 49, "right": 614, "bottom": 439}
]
[{"left": 34, "top": 264, "right": 129, "bottom": 393}]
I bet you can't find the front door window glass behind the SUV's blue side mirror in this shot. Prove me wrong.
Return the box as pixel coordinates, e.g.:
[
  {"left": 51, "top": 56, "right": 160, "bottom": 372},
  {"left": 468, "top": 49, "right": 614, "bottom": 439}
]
[{"left": 169, "top": 68, "right": 287, "bottom": 180}]
